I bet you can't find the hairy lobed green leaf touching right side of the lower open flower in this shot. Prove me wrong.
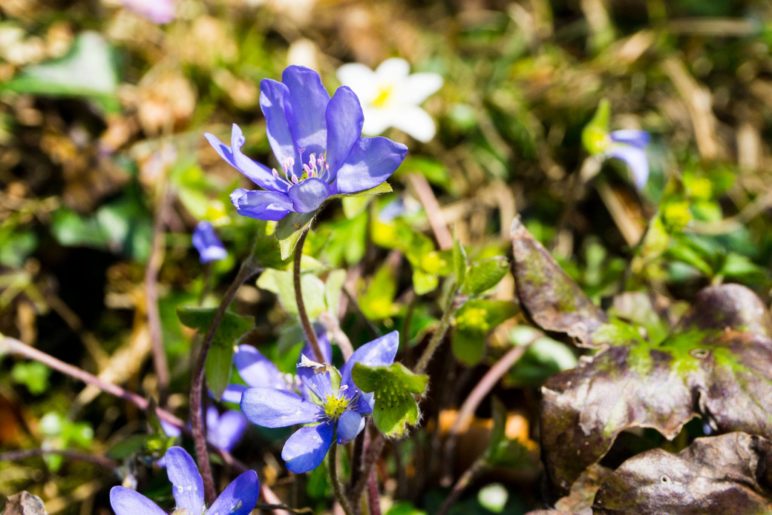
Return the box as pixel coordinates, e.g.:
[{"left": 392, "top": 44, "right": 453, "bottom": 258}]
[{"left": 352, "top": 363, "right": 429, "bottom": 438}]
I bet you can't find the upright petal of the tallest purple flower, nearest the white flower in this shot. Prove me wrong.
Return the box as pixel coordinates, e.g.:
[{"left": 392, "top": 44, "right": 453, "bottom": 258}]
[{"left": 326, "top": 86, "right": 364, "bottom": 172}]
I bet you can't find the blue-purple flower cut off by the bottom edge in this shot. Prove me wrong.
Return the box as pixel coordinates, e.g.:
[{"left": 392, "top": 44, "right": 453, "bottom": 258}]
[{"left": 110, "top": 447, "right": 260, "bottom": 515}]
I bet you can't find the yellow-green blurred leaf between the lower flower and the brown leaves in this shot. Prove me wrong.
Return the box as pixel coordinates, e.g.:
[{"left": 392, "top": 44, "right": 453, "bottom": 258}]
[{"left": 451, "top": 299, "right": 517, "bottom": 366}]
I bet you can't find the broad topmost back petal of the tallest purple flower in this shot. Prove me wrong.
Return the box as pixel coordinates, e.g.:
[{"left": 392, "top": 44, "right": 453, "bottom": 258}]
[{"left": 282, "top": 66, "right": 330, "bottom": 160}]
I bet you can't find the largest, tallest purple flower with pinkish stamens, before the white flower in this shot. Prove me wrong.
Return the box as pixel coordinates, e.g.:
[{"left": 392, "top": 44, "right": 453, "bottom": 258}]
[{"left": 205, "top": 66, "right": 407, "bottom": 220}]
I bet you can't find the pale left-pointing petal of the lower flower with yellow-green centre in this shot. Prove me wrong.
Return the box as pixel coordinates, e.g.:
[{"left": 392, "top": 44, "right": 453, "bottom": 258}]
[{"left": 241, "top": 388, "right": 323, "bottom": 427}]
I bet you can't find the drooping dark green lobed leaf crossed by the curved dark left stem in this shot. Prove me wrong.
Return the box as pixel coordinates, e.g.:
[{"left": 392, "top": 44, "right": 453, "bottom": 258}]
[{"left": 177, "top": 307, "right": 253, "bottom": 400}]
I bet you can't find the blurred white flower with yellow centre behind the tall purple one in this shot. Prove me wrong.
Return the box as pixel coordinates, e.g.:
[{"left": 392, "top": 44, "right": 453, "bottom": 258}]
[{"left": 338, "top": 58, "right": 442, "bottom": 142}]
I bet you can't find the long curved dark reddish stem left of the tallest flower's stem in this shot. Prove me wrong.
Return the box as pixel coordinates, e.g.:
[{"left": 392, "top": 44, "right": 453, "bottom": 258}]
[{"left": 190, "top": 254, "right": 259, "bottom": 504}]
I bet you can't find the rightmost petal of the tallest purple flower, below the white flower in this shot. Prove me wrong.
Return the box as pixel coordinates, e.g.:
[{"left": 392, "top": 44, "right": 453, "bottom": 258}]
[{"left": 335, "top": 137, "right": 407, "bottom": 193}]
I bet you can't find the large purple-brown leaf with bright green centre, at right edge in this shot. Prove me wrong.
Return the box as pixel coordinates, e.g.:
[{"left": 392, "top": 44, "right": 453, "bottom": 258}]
[{"left": 541, "top": 285, "right": 772, "bottom": 492}]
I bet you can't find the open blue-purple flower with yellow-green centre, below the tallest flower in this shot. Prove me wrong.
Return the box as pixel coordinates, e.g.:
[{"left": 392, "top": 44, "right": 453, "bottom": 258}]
[{"left": 241, "top": 331, "right": 399, "bottom": 474}]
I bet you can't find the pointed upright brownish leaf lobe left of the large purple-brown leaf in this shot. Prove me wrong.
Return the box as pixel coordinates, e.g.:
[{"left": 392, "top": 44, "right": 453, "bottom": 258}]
[{"left": 510, "top": 218, "right": 606, "bottom": 347}]
